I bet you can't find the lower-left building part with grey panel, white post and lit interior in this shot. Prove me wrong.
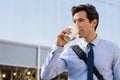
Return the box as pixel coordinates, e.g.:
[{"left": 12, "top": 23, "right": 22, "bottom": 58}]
[{"left": 0, "top": 40, "right": 50, "bottom": 80}]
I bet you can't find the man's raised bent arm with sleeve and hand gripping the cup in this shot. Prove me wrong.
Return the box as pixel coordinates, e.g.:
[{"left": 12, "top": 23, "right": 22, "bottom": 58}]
[{"left": 41, "top": 28, "right": 75, "bottom": 80}]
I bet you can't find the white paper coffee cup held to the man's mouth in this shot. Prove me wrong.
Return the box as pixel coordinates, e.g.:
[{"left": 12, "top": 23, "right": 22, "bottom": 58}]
[{"left": 64, "top": 24, "right": 79, "bottom": 42}]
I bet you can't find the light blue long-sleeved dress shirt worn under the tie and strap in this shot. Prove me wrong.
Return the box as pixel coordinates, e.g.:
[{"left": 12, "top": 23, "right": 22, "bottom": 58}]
[{"left": 41, "top": 37, "right": 120, "bottom": 80}]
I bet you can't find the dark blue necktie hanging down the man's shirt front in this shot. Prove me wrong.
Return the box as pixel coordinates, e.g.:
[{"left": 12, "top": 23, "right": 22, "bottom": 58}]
[{"left": 87, "top": 43, "right": 94, "bottom": 80}]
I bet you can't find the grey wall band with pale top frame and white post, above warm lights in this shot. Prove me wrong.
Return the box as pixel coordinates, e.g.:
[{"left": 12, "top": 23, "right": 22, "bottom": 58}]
[{"left": 0, "top": 40, "right": 51, "bottom": 68}]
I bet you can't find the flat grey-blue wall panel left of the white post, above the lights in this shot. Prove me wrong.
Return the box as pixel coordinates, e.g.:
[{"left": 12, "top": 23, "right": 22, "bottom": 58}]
[{"left": 0, "top": 44, "right": 37, "bottom": 68}]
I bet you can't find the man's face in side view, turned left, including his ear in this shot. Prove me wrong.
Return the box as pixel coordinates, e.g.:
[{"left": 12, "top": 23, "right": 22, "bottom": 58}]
[{"left": 73, "top": 11, "right": 95, "bottom": 38}]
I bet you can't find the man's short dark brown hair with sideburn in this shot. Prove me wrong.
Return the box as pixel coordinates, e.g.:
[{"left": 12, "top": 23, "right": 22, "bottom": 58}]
[{"left": 71, "top": 4, "right": 99, "bottom": 30}]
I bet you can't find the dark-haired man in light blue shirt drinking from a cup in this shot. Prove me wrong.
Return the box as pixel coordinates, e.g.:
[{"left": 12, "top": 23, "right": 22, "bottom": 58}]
[{"left": 41, "top": 4, "right": 120, "bottom": 80}]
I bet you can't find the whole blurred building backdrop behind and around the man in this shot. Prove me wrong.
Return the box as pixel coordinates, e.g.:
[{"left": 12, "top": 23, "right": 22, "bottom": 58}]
[{"left": 0, "top": 0, "right": 120, "bottom": 80}]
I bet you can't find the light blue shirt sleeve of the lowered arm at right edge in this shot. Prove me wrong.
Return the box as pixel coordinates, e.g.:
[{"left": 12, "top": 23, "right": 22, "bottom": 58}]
[{"left": 113, "top": 48, "right": 120, "bottom": 80}]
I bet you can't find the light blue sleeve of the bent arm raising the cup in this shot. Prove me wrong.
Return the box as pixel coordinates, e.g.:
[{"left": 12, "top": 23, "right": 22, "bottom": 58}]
[{"left": 41, "top": 45, "right": 66, "bottom": 80}]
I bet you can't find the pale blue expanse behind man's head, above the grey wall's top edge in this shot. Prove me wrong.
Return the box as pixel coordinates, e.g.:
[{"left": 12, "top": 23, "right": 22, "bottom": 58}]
[{"left": 0, "top": 0, "right": 120, "bottom": 46}]
